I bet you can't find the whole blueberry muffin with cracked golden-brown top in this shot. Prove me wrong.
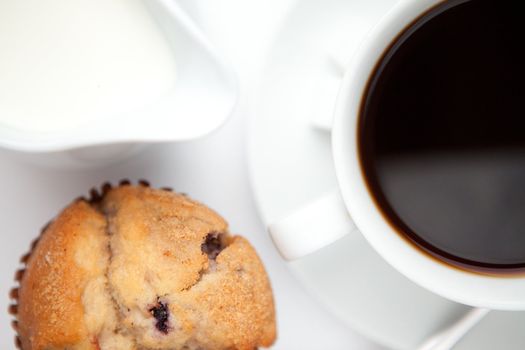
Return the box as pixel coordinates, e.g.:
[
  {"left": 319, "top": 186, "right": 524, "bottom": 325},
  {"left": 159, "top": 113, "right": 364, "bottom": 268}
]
[{"left": 11, "top": 182, "right": 276, "bottom": 350}]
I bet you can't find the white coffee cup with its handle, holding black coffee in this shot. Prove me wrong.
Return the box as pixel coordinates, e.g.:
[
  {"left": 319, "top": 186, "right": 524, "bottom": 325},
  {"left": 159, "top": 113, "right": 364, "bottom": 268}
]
[{"left": 269, "top": 0, "right": 525, "bottom": 310}]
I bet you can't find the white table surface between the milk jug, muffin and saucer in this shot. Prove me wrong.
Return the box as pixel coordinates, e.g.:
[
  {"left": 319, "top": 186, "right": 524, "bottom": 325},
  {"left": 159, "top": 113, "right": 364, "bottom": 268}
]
[{"left": 0, "top": 0, "right": 380, "bottom": 350}]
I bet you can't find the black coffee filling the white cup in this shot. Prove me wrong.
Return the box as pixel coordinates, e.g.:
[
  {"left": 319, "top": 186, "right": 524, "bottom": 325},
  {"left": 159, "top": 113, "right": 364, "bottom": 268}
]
[{"left": 358, "top": 0, "right": 525, "bottom": 273}]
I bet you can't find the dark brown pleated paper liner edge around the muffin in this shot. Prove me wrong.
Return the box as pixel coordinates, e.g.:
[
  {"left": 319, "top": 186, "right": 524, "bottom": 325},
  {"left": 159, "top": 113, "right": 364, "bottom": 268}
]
[{"left": 8, "top": 179, "right": 169, "bottom": 350}]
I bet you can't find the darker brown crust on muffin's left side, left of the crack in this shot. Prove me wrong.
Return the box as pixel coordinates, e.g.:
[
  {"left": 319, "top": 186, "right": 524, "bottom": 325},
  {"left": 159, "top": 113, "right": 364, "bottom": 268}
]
[{"left": 18, "top": 202, "right": 105, "bottom": 350}]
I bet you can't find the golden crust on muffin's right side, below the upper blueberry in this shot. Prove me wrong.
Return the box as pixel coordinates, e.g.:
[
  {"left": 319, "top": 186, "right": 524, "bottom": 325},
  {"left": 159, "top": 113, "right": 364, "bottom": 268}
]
[{"left": 178, "top": 236, "right": 276, "bottom": 350}]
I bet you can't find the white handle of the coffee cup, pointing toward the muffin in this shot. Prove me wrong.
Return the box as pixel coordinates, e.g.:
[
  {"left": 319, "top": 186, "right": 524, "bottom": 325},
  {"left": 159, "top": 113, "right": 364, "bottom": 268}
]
[{"left": 268, "top": 191, "right": 357, "bottom": 260}]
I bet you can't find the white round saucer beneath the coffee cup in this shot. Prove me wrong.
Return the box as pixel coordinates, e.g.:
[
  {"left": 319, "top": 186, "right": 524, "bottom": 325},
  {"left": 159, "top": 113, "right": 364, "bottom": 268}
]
[{"left": 250, "top": 0, "right": 525, "bottom": 350}]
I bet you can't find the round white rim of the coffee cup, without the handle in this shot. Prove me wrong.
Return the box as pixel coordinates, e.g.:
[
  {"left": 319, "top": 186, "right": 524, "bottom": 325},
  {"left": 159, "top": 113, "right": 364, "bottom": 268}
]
[{"left": 332, "top": 0, "right": 525, "bottom": 310}]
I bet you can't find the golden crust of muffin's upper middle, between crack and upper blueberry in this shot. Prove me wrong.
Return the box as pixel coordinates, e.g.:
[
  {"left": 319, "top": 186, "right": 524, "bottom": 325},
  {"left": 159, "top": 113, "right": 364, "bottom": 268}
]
[{"left": 102, "top": 186, "right": 227, "bottom": 303}]
